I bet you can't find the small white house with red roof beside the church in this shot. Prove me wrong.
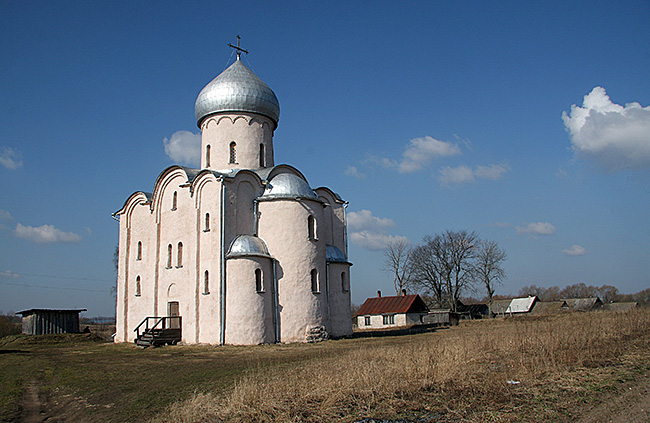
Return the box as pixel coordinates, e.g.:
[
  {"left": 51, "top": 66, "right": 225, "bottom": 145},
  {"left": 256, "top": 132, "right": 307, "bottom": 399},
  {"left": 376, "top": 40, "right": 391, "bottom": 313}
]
[{"left": 357, "top": 291, "right": 429, "bottom": 329}]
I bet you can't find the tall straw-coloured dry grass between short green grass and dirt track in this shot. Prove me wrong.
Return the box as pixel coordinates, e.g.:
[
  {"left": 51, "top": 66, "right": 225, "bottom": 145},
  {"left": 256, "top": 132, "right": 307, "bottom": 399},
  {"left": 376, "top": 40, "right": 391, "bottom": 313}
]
[{"left": 155, "top": 309, "right": 650, "bottom": 422}]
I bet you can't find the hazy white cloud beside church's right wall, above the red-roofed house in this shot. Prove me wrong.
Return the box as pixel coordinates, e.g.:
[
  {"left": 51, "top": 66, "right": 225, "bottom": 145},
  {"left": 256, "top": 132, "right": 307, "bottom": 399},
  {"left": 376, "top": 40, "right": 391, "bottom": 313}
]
[{"left": 347, "top": 210, "right": 409, "bottom": 250}]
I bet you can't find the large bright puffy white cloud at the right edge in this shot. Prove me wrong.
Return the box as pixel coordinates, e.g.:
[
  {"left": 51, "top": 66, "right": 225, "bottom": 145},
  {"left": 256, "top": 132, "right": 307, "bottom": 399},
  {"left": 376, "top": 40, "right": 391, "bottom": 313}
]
[{"left": 562, "top": 87, "right": 650, "bottom": 171}]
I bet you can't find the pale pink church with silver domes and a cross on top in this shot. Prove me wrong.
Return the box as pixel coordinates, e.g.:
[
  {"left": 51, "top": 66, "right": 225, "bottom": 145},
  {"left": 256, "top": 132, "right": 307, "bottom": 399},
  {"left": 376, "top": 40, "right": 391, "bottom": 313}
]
[{"left": 114, "top": 46, "right": 352, "bottom": 345}]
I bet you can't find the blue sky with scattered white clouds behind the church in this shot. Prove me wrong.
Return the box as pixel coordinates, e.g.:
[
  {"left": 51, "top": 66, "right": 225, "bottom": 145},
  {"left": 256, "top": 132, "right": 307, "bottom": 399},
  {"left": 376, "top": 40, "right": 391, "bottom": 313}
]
[{"left": 0, "top": 1, "right": 650, "bottom": 316}]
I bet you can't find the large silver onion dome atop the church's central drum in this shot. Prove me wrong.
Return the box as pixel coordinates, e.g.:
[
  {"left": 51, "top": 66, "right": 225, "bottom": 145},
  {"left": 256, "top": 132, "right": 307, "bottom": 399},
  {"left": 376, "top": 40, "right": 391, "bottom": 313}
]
[{"left": 194, "top": 60, "right": 280, "bottom": 126}]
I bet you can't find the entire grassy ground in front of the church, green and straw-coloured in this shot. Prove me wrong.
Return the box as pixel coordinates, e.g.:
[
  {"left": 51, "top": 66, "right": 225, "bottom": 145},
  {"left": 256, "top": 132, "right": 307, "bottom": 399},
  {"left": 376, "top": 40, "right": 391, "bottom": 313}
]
[{"left": 0, "top": 309, "right": 650, "bottom": 422}]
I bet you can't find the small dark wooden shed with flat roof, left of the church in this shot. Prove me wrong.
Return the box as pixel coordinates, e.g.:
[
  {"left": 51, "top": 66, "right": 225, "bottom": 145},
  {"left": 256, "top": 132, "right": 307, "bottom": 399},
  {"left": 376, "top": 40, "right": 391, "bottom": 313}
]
[{"left": 16, "top": 308, "right": 86, "bottom": 335}]
